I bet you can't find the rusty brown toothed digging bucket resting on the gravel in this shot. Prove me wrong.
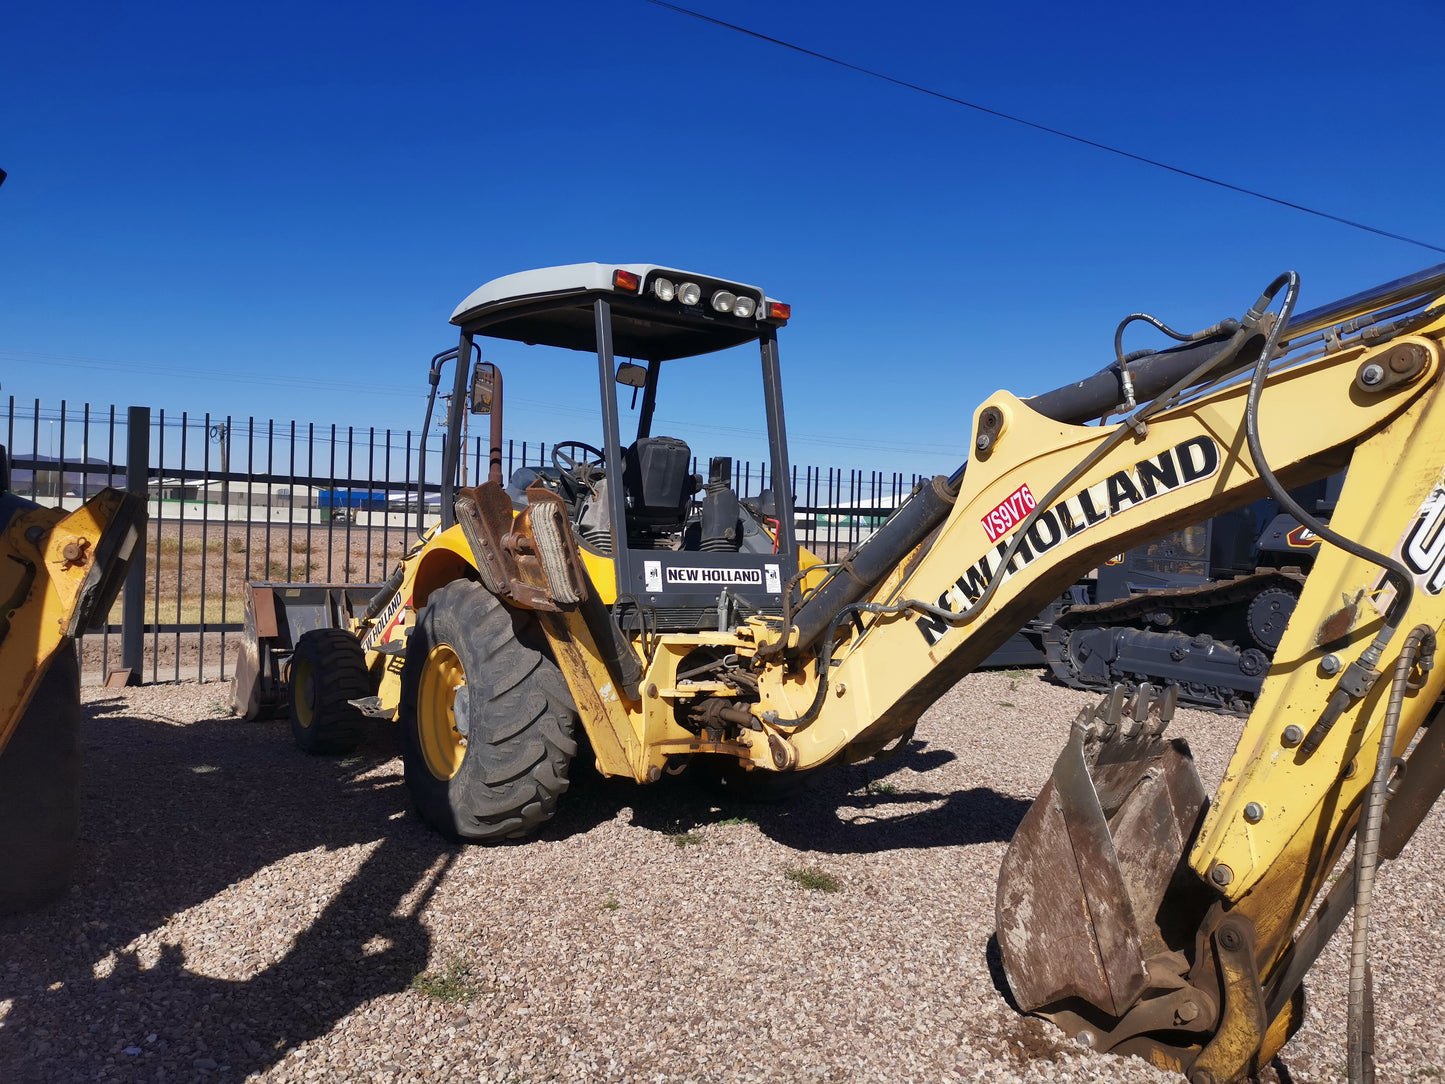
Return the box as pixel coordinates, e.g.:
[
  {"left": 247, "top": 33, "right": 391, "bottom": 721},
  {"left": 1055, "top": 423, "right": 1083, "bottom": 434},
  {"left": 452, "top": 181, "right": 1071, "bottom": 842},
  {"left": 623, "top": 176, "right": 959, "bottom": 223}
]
[{"left": 996, "top": 685, "right": 1208, "bottom": 1049}]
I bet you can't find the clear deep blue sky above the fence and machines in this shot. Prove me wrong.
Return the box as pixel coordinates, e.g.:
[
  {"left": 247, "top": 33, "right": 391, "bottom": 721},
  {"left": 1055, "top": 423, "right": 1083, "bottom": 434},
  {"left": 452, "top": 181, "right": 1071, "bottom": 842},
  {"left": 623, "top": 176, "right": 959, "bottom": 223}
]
[{"left": 0, "top": 0, "right": 1445, "bottom": 471}]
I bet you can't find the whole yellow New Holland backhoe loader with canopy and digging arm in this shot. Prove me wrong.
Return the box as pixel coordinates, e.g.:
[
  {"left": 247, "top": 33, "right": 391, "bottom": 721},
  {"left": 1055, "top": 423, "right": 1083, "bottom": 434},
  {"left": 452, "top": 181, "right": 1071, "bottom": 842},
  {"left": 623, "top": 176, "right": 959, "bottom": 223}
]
[{"left": 238, "top": 264, "right": 1445, "bottom": 1084}]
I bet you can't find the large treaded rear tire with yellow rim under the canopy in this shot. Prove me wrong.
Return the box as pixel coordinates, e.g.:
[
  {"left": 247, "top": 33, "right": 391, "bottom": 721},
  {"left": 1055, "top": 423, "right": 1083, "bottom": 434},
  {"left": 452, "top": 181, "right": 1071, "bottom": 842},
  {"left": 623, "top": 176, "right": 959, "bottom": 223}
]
[{"left": 400, "top": 580, "right": 577, "bottom": 843}]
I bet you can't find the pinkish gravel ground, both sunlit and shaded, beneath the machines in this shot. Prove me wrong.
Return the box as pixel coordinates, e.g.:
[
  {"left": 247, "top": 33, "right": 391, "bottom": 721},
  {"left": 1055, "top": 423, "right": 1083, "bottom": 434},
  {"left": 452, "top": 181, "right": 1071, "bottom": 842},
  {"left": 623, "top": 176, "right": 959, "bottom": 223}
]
[{"left": 0, "top": 672, "right": 1445, "bottom": 1084}]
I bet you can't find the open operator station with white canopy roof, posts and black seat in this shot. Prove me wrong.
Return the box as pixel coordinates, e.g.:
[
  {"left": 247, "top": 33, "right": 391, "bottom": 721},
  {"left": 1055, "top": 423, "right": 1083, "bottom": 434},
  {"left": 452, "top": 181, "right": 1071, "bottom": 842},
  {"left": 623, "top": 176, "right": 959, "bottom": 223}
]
[{"left": 451, "top": 263, "right": 799, "bottom": 632}]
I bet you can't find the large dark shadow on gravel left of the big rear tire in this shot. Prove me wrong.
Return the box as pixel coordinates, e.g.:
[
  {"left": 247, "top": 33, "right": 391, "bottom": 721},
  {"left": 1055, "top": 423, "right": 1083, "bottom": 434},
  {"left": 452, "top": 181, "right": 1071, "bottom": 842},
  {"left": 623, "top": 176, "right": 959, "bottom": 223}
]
[{"left": 0, "top": 701, "right": 455, "bottom": 1084}]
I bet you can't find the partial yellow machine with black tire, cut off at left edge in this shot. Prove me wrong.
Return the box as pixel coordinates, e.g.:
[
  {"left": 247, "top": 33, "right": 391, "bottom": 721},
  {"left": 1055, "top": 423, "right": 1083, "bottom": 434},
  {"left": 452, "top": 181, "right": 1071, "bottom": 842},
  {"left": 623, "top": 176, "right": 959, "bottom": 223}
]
[{"left": 0, "top": 448, "right": 146, "bottom": 913}]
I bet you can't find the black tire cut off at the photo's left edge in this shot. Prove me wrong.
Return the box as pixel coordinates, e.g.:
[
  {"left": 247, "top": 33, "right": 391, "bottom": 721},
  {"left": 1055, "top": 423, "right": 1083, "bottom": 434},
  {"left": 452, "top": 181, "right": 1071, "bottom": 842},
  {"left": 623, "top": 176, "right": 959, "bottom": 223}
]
[{"left": 0, "top": 645, "right": 81, "bottom": 915}]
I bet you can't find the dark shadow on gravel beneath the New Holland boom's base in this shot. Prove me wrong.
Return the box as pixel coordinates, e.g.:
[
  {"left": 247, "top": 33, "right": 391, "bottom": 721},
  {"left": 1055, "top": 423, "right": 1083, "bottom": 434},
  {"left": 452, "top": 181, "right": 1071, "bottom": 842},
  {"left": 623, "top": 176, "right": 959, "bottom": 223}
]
[{"left": 545, "top": 741, "right": 1030, "bottom": 854}]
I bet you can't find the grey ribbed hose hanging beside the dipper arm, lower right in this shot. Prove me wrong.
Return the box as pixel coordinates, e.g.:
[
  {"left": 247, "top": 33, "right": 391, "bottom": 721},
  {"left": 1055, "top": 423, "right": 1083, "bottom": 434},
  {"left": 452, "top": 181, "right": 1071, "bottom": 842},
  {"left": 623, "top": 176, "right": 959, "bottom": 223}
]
[{"left": 1347, "top": 624, "right": 1435, "bottom": 1084}]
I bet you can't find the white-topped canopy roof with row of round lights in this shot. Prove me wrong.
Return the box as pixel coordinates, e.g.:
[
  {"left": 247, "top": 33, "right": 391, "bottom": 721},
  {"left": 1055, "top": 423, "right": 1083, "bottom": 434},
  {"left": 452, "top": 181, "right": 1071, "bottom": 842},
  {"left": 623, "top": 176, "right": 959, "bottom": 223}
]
[{"left": 451, "top": 263, "right": 789, "bottom": 361}]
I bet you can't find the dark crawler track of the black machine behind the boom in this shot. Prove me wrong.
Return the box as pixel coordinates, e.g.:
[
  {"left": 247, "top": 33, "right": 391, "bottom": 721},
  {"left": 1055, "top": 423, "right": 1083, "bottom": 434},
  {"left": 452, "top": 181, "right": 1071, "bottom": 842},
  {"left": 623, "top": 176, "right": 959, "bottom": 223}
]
[{"left": 1043, "top": 569, "right": 1303, "bottom": 715}]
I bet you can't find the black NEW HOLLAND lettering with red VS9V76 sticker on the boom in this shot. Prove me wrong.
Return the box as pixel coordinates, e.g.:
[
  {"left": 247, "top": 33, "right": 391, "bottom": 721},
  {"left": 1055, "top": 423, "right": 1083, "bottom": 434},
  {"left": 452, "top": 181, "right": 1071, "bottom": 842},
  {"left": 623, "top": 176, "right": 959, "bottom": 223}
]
[{"left": 918, "top": 436, "right": 1220, "bottom": 646}]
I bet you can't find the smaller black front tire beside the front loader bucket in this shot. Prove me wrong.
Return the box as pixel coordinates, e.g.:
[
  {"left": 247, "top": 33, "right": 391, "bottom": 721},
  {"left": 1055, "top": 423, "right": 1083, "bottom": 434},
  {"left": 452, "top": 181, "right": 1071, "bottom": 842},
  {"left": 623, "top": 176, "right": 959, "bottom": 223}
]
[{"left": 290, "top": 629, "right": 376, "bottom": 754}]
